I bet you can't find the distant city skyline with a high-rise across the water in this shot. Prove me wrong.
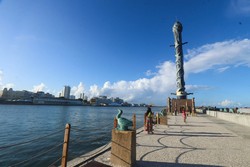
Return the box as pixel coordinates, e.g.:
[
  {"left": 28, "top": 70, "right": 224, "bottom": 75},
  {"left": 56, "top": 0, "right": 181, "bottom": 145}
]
[{"left": 0, "top": 86, "right": 147, "bottom": 107}]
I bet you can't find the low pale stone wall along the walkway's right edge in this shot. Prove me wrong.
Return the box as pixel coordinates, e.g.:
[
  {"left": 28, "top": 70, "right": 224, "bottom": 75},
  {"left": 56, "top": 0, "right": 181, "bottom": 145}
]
[{"left": 206, "top": 110, "right": 250, "bottom": 127}]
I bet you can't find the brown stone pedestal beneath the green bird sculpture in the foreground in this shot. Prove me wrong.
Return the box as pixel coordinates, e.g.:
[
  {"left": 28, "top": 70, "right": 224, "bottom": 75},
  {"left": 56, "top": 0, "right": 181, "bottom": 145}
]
[{"left": 111, "top": 129, "right": 136, "bottom": 167}]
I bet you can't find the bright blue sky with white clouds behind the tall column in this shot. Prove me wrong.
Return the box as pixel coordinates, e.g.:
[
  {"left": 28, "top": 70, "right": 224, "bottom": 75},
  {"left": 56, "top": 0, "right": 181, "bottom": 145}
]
[{"left": 0, "top": 0, "right": 250, "bottom": 107}]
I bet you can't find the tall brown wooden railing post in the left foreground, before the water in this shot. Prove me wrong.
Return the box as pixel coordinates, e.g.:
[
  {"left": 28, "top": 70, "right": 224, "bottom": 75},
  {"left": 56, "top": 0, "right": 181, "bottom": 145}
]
[{"left": 61, "top": 124, "right": 70, "bottom": 167}]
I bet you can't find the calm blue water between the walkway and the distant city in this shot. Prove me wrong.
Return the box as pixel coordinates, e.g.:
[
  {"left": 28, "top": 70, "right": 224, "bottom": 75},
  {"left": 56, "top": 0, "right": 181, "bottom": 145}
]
[{"left": 0, "top": 105, "right": 164, "bottom": 167}]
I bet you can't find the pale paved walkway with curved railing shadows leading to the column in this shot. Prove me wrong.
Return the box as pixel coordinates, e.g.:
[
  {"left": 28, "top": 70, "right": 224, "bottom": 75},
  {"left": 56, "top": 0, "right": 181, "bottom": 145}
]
[{"left": 79, "top": 115, "right": 250, "bottom": 167}]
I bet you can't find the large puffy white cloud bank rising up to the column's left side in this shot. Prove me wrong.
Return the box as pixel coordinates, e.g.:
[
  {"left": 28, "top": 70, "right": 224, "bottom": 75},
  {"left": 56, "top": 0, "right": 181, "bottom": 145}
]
[{"left": 83, "top": 61, "right": 175, "bottom": 104}]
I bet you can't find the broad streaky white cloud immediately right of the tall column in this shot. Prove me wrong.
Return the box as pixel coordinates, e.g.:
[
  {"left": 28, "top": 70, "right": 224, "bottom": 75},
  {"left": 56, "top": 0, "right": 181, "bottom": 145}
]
[{"left": 184, "top": 39, "right": 250, "bottom": 74}]
